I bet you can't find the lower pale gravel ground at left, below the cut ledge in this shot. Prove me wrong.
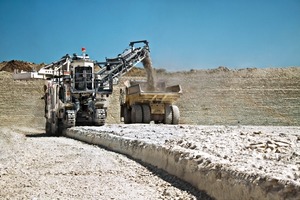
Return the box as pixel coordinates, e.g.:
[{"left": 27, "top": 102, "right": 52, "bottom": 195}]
[{"left": 0, "top": 127, "right": 210, "bottom": 199}]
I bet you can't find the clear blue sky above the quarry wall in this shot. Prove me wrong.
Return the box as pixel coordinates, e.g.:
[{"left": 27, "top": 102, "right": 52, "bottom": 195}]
[{"left": 0, "top": 0, "right": 300, "bottom": 71}]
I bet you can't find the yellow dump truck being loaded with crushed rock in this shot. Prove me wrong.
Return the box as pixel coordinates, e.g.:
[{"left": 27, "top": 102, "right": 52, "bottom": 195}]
[{"left": 120, "top": 81, "right": 182, "bottom": 124}]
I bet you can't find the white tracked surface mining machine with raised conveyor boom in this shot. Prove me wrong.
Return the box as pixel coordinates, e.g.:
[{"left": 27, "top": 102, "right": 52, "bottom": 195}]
[{"left": 38, "top": 40, "right": 149, "bottom": 134}]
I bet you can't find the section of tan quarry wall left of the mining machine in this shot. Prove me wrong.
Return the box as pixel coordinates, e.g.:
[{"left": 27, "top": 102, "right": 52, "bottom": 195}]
[{"left": 0, "top": 71, "right": 45, "bottom": 127}]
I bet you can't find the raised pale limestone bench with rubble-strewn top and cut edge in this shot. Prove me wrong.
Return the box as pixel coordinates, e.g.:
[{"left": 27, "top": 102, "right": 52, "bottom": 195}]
[{"left": 66, "top": 124, "right": 300, "bottom": 200}]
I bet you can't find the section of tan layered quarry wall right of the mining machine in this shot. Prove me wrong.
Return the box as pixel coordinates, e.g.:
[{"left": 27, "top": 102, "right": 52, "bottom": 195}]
[{"left": 109, "top": 67, "right": 300, "bottom": 126}]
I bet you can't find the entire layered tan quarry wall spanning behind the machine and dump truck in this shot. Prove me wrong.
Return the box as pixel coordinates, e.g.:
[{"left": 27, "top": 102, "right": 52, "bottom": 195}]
[{"left": 0, "top": 63, "right": 300, "bottom": 126}]
